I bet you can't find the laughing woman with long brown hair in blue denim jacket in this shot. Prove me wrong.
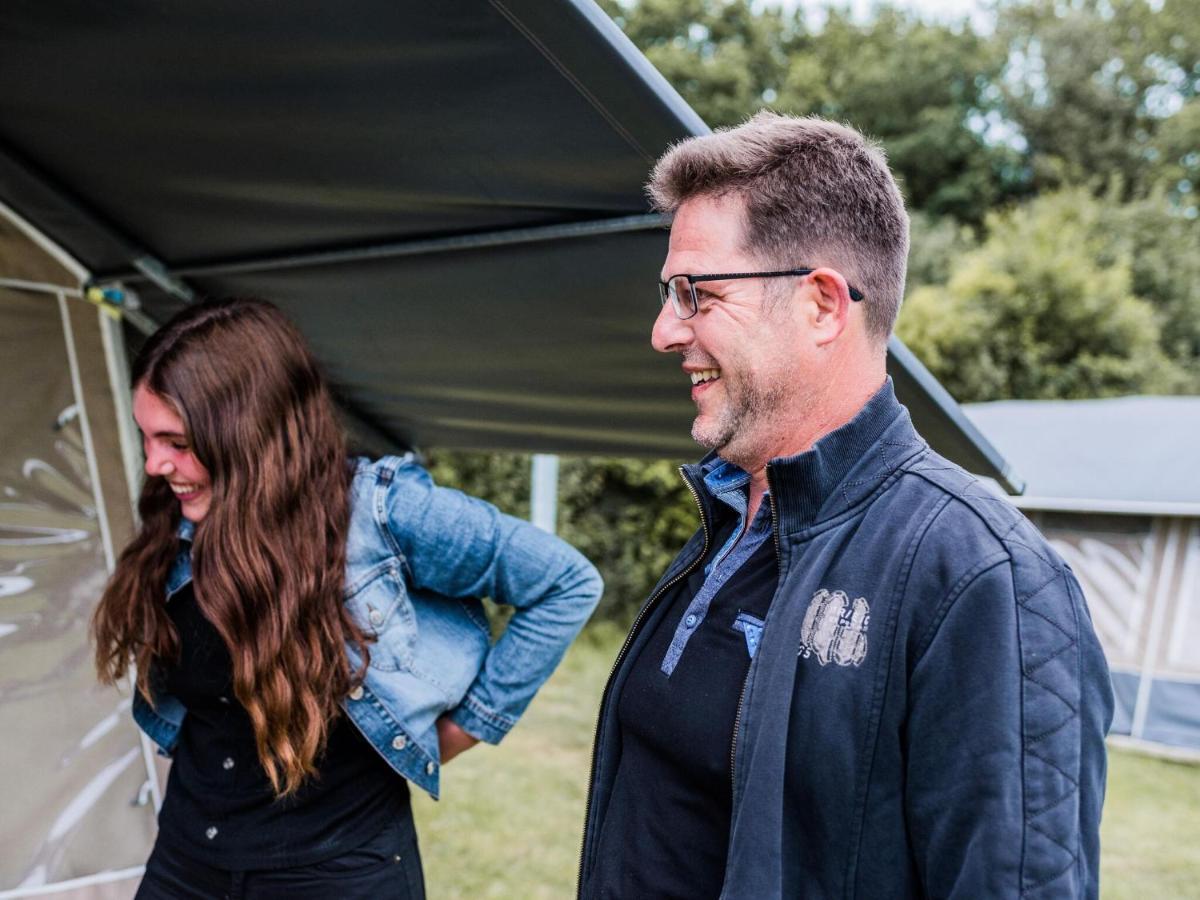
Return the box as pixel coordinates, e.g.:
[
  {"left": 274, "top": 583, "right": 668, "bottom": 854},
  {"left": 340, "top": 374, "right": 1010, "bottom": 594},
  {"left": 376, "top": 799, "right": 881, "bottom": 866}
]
[{"left": 92, "top": 300, "right": 600, "bottom": 900}]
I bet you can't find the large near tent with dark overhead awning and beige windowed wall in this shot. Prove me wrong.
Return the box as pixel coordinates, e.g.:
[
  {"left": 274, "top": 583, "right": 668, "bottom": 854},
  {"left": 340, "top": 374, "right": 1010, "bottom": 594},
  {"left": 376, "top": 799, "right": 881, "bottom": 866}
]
[{"left": 0, "top": 0, "right": 1015, "bottom": 898}]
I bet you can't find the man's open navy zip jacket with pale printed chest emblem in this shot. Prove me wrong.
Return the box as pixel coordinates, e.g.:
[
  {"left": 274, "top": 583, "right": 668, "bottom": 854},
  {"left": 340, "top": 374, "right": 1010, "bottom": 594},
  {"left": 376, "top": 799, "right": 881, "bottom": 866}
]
[{"left": 581, "top": 382, "right": 1112, "bottom": 900}]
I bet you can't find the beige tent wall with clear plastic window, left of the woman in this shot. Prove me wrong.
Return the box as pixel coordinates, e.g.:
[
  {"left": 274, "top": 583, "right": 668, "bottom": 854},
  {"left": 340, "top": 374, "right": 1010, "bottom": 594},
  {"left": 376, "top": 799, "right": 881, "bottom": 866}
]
[{"left": 0, "top": 218, "right": 157, "bottom": 900}]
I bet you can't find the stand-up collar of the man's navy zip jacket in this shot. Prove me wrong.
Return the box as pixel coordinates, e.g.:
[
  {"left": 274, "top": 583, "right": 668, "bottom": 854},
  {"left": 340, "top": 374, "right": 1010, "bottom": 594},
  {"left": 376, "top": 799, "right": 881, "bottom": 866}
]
[{"left": 685, "top": 377, "right": 926, "bottom": 534}]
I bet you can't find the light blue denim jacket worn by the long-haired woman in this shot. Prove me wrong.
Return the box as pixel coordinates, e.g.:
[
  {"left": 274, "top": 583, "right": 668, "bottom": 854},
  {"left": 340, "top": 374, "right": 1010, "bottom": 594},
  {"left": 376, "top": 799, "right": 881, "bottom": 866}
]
[{"left": 133, "top": 456, "right": 602, "bottom": 799}]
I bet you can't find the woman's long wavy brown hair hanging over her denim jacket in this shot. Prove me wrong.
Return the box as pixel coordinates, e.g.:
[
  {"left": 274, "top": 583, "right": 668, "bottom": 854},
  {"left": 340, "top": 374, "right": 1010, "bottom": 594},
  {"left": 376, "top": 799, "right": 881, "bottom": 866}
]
[{"left": 91, "top": 300, "right": 368, "bottom": 796}]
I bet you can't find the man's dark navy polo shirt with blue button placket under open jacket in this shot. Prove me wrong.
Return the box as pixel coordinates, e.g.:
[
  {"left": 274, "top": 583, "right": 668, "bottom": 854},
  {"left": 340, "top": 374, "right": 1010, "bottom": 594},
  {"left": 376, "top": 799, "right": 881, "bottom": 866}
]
[{"left": 589, "top": 463, "right": 779, "bottom": 900}]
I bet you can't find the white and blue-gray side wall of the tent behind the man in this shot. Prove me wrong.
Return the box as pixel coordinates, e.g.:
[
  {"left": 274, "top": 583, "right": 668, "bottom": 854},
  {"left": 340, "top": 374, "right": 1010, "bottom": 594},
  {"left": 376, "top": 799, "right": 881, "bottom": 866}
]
[{"left": 1030, "top": 511, "right": 1200, "bottom": 750}]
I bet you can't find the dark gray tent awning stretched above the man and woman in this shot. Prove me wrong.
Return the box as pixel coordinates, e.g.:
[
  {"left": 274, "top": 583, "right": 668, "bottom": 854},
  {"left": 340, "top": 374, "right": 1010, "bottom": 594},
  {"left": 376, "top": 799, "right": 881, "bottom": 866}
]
[{"left": 0, "top": 0, "right": 1008, "bottom": 494}]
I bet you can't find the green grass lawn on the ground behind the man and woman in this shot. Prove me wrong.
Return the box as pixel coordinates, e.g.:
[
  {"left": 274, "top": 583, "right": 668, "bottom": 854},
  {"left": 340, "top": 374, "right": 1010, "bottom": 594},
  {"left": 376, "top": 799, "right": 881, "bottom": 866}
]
[{"left": 414, "top": 626, "right": 1200, "bottom": 900}]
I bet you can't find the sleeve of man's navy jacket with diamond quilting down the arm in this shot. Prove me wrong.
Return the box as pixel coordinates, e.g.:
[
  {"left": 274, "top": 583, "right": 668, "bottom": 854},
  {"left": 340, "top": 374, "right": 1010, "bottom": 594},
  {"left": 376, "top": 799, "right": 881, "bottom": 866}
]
[{"left": 905, "top": 548, "right": 1112, "bottom": 898}]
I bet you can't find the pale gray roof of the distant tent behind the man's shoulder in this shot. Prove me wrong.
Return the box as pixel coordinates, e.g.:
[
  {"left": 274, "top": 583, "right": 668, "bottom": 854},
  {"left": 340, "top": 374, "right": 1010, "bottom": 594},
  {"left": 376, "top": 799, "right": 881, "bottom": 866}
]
[{"left": 964, "top": 397, "right": 1200, "bottom": 515}]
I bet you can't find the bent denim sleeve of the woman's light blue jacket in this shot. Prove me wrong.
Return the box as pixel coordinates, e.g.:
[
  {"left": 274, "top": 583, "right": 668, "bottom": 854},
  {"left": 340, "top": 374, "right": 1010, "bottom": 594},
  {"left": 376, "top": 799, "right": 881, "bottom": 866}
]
[{"left": 385, "top": 464, "right": 602, "bottom": 744}]
